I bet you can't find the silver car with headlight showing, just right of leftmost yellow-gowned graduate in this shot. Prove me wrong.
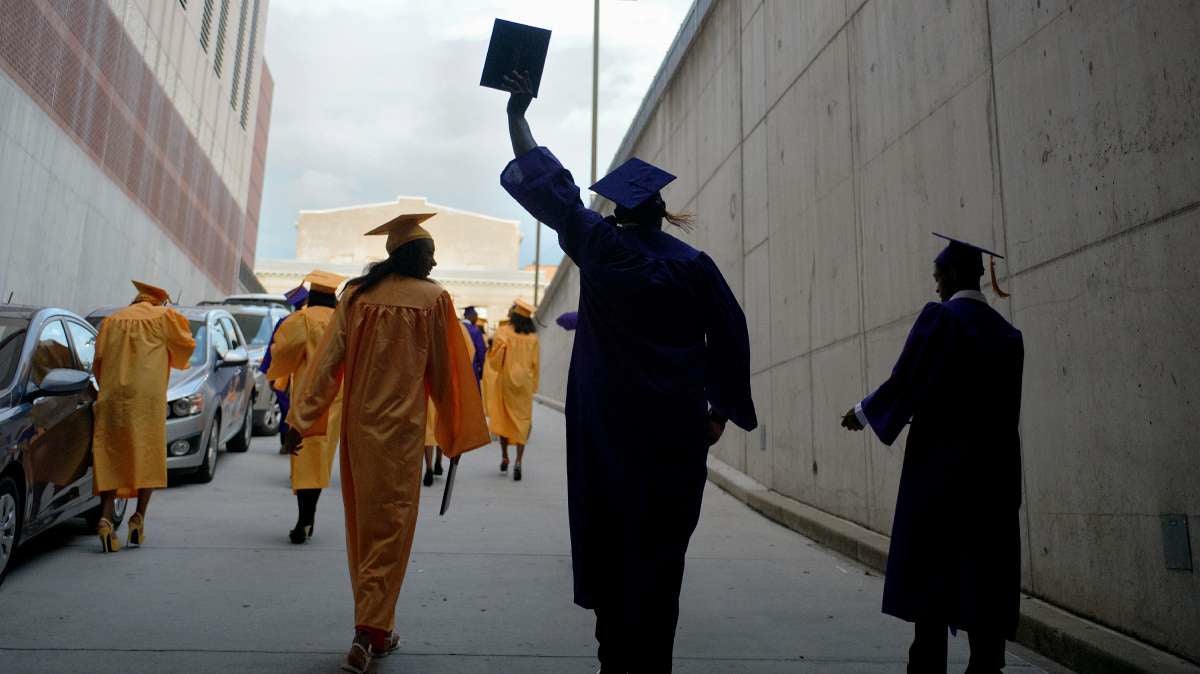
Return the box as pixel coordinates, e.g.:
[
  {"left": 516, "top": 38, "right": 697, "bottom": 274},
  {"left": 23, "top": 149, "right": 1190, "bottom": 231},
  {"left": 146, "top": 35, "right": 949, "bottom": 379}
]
[{"left": 88, "top": 306, "right": 254, "bottom": 482}]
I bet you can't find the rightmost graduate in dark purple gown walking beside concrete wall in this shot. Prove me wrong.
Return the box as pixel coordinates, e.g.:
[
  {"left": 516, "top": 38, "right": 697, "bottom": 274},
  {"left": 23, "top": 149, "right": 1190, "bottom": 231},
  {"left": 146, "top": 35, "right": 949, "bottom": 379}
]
[{"left": 842, "top": 235, "right": 1025, "bottom": 674}]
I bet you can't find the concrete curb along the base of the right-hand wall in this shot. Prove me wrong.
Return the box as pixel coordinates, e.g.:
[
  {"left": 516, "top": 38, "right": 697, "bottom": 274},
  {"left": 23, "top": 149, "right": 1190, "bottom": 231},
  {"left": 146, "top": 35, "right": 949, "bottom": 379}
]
[{"left": 700, "top": 453, "right": 1200, "bottom": 674}]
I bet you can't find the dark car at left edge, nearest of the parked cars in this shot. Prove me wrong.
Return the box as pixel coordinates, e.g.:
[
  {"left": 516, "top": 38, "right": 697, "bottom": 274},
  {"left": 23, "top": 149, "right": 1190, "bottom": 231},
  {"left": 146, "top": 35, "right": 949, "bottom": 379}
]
[{"left": 0, "top": 305, "right": 126, "bottom": 580}]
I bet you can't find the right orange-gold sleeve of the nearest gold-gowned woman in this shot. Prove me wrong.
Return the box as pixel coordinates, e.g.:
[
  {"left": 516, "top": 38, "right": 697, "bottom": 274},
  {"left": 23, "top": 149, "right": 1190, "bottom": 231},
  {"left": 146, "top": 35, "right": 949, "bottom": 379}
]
[{"left": 425, "top": 293, "right": 492, "bottom": 458}]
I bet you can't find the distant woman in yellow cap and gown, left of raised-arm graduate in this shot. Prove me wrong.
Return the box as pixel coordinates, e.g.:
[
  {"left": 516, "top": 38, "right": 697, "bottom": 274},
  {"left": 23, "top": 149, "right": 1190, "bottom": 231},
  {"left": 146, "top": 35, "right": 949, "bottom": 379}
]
[{"left": 484, "top": 299, "right": 539, "bottom": 481}]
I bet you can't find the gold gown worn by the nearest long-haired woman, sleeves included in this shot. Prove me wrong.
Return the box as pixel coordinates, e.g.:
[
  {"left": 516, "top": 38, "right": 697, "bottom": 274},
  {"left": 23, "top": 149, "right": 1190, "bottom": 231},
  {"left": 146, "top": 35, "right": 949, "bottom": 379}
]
[{"left": 288, "top": 277, "right": 488, "bottom": 631}]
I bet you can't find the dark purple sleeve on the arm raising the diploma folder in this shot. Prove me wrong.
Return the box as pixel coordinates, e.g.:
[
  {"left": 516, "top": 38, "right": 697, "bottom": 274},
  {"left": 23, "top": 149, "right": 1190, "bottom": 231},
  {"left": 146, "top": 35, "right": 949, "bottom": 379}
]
[{"left": 500, "top": 148, "right": 613, "bottom": 267}]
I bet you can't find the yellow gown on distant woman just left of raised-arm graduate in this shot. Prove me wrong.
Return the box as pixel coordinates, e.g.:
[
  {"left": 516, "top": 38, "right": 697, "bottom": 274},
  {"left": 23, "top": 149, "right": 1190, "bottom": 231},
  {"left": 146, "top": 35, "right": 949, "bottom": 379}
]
[{"left": 484, "top": 326, "right": 538, "bottom": 445}]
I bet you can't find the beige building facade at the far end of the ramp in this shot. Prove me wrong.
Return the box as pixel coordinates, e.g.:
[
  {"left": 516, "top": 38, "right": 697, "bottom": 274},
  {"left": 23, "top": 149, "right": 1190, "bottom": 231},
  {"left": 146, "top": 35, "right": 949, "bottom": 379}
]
[{"left": 256, "top": 197, "right": 550, "bottom": 326}]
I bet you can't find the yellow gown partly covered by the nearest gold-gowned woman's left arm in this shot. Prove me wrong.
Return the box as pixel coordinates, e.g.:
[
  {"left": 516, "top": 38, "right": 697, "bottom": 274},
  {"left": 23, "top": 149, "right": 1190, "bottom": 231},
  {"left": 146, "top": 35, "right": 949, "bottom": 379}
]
[{"left": 266, "top": 307, "right": 342, "bottom": 492}]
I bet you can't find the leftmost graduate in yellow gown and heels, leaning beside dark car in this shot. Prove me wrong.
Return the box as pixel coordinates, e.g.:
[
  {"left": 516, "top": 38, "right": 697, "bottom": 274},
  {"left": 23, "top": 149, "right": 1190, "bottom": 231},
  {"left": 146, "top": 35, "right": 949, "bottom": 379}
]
[{"left": 91, "top": 281, "right": 196, "bottom": 552}]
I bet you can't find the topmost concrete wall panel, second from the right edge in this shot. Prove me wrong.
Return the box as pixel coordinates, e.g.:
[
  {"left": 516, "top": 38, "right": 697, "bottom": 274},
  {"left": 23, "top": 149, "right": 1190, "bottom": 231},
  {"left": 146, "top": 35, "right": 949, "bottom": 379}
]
[{"left": 851, "top": 0, "right": 989, "bottom": 164}]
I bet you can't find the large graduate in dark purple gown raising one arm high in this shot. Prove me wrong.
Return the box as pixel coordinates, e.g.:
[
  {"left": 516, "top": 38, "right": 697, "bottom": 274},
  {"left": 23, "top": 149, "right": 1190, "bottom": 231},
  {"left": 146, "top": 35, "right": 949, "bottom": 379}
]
[{"left": 500, "top": 73, "right": 757, "bottom": 672}]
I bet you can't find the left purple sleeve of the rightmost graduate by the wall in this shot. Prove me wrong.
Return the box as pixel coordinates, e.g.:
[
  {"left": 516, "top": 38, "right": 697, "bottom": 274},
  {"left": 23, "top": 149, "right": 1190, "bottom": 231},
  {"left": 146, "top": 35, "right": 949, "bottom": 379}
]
[{"left": 862, "top": 302, "right": 948, "bottom": 445}]
